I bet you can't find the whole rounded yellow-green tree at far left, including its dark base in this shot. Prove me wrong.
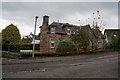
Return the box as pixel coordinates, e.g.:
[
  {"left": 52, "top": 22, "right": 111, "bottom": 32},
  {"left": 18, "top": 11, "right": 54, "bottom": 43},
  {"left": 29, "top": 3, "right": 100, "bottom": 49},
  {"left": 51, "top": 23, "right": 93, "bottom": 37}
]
[{"left": 2, "top": 24, "right": 21, "bottom": 51}]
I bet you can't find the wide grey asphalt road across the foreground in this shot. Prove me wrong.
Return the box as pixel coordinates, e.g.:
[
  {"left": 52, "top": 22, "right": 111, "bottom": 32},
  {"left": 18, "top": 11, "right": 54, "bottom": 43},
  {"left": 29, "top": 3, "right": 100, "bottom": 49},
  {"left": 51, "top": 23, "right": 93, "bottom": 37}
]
[{"left": 2, "top": 52, "right": 118, "bottom": 78}]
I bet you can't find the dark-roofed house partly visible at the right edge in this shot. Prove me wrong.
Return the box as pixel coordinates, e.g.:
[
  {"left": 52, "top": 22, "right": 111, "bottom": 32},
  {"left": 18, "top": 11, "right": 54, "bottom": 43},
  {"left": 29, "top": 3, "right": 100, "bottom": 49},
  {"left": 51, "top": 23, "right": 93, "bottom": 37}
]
[{"left": 104, "top": 29, "right": 120, "bottom": 43}]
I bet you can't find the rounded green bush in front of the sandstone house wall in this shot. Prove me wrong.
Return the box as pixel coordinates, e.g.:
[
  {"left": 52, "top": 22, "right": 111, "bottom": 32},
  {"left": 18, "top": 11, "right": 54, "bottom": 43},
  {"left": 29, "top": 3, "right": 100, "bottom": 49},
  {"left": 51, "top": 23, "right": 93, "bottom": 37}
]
[{"left": 56, "top": 41, "right": 77, "bottom": 53}]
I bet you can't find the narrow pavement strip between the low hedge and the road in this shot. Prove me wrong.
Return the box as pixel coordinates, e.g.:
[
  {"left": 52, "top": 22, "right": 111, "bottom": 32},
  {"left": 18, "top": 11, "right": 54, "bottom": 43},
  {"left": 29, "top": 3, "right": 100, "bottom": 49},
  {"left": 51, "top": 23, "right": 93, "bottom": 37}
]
[{"left": 2, "top": 51, "right": 120, "bottom": 65}]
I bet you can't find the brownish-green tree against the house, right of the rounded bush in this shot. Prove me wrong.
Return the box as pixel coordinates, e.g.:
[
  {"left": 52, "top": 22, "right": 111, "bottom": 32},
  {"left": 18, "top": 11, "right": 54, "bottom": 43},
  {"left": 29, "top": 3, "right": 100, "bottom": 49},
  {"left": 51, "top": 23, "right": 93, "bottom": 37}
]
[{"left": 71, "top": 29, "right": 89, "bottom": 49}]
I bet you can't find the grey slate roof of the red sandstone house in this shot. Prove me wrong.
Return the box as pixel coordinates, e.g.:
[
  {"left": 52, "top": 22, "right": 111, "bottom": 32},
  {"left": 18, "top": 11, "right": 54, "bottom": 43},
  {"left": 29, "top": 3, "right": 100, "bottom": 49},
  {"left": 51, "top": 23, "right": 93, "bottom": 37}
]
[{"left": 48, "top": 22, "right": 106, "bottom": 39}]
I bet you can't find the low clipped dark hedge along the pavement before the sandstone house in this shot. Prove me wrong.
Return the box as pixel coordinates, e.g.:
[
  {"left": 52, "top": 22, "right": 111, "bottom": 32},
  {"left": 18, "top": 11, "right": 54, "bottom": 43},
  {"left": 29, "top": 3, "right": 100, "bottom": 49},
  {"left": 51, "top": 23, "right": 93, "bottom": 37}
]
[{"left": 20, "top": 50, "right": 104, "bottom": 58}]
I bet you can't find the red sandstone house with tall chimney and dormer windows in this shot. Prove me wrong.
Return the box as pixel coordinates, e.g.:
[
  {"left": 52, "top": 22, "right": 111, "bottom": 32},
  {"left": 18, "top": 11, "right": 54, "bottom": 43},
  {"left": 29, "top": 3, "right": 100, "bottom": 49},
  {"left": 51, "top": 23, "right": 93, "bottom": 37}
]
[{"left": 40, "top": 16, "right": 105, "bottom": 52}]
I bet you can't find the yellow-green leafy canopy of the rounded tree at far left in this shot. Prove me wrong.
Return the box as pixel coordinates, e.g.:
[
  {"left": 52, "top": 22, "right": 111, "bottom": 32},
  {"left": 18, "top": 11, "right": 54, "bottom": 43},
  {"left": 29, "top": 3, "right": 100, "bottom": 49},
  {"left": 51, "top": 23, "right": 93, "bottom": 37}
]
[{"left": 2, "top": 24, "right": 21, "bottom": 51}]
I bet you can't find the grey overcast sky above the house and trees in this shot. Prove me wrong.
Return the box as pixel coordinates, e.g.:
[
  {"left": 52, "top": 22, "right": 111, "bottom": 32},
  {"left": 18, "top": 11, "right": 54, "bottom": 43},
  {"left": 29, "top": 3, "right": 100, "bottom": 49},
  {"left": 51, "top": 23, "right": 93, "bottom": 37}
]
[{"left": 0, "top": 2, "right": 118, "bottom": 37}]
